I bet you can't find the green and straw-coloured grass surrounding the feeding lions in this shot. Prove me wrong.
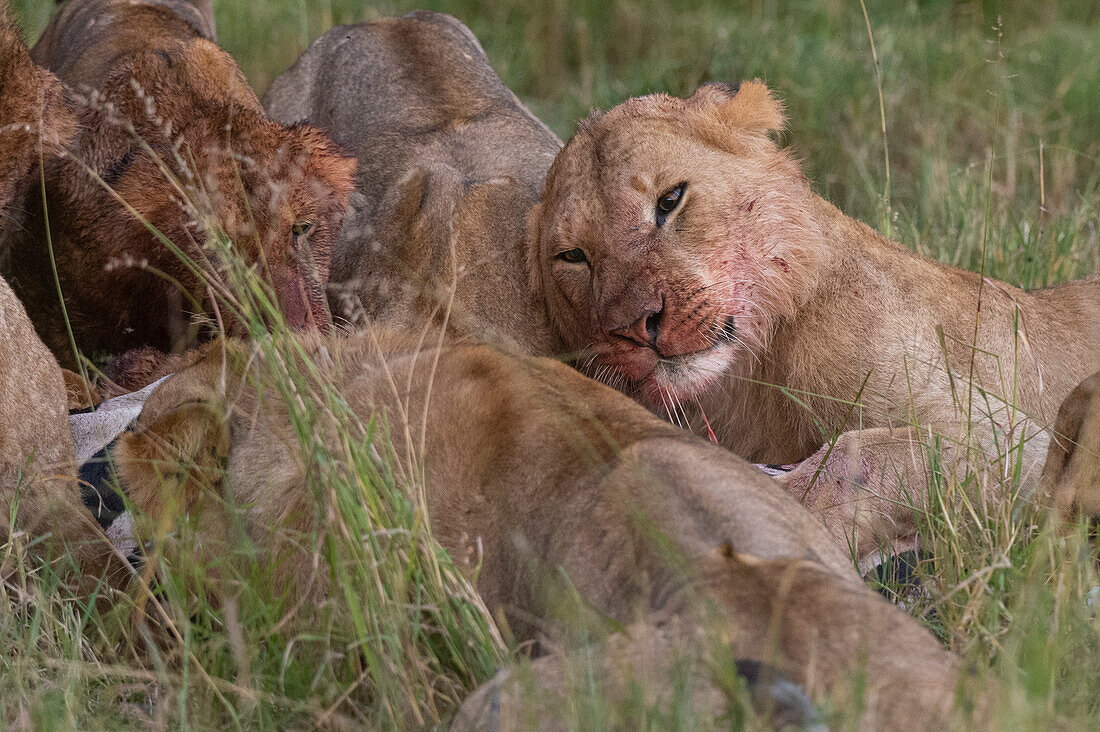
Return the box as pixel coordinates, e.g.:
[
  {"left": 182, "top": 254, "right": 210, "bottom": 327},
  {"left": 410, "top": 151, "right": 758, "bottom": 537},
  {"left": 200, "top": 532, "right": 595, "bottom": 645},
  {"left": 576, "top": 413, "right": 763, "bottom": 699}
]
[{"left": 0, "top": 0, "right": 1100, "bottom": 729}]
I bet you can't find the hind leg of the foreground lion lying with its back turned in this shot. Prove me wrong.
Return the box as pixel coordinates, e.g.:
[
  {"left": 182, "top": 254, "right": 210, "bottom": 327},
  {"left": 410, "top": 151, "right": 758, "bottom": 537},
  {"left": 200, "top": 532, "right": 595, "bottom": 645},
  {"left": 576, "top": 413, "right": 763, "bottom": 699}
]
[{"left": 699, "top": 550, "right": 981, "bottom": 730}]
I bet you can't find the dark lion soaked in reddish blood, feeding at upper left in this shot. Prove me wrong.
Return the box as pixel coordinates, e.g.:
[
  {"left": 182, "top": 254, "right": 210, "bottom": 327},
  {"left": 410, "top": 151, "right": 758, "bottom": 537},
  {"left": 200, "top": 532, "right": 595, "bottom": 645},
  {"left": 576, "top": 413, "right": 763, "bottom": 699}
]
[{"left": 0, "top": 0, "right": 355, "bottom": 368}]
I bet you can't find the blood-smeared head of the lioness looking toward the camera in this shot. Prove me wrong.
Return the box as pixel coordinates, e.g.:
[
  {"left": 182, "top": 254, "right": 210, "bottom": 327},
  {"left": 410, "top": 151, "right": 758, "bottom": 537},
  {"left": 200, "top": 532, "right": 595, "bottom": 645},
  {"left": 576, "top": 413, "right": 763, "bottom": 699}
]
[{"left": 530, "top": 81, "right": 813, "bottom": 405}]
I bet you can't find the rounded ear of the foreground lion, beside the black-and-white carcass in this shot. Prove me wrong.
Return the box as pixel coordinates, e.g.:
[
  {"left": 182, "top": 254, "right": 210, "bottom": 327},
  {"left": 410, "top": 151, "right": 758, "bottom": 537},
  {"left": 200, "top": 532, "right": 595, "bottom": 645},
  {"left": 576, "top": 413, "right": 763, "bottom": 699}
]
[{"left": 114, "top": 402, "right": 229, "bottom": 520}]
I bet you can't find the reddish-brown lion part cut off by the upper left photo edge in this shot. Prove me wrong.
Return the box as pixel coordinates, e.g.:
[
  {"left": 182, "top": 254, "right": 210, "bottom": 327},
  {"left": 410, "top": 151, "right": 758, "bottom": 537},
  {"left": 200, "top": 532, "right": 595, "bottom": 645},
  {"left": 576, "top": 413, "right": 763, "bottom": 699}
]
[{"left": 0, "top": 3, "right": 76, "bottom": 220}]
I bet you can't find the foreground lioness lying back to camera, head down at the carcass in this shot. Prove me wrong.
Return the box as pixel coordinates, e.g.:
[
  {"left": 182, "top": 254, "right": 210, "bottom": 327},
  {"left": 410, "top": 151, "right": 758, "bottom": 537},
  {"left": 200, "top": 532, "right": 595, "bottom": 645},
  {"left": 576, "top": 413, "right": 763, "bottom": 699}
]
[{"left": 114, "top": 330, "right": 981, "bottom": 729}]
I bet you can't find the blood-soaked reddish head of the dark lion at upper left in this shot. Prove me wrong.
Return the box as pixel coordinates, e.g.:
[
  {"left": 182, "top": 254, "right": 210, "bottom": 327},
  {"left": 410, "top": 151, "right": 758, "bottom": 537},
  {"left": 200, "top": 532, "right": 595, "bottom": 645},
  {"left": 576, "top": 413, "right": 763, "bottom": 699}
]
[{"left": 113, "top": 114, "right": 354, "bottom": 335}]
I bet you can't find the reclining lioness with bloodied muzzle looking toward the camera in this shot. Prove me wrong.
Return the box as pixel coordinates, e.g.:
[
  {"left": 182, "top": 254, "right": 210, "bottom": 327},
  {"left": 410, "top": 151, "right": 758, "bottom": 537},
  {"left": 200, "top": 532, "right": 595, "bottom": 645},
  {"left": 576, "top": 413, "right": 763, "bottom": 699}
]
[{"left": 530, "top": 81, "right": 1100, "bottom": 556}]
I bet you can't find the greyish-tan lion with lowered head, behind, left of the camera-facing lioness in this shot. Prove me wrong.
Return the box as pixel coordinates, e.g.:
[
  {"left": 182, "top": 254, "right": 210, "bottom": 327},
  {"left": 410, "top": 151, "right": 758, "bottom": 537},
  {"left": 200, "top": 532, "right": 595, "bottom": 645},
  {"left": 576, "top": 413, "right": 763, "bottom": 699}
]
[{"left": 264, "top": 11, "right": 561, "bottom": 356}]
